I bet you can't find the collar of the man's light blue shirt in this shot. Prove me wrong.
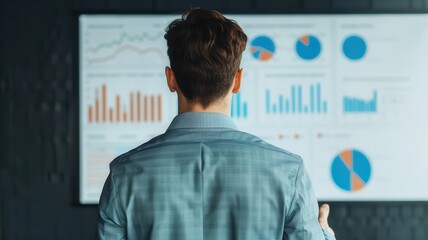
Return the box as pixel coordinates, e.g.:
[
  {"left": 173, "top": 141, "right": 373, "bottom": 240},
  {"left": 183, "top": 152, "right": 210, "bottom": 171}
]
[{"left": 167, "top": 112, "right": 238, "bottom": 131}]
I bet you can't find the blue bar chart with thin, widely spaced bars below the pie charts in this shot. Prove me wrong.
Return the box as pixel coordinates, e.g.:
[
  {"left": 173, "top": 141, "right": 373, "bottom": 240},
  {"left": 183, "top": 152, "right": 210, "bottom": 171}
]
[{"left": 265, "top": 83, "right": 328, "bottom": 114}]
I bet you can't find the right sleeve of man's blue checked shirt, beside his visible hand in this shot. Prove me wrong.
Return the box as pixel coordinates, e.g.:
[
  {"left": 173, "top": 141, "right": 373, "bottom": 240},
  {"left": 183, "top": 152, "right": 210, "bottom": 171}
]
[{"left": 284, "top": 161, "right": 335, "bottom": 240}]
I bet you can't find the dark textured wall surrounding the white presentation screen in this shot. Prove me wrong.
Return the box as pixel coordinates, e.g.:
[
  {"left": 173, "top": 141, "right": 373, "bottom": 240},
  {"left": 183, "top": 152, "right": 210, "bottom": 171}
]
[{"left": 0, "top": 0, "right": 428, "bottom": 240}]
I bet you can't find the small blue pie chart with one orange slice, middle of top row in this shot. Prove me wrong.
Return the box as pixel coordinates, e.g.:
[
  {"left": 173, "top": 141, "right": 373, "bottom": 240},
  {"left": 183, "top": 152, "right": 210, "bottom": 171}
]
[{"left": 296, "top": 35, "right": 321, "bottom": 60}]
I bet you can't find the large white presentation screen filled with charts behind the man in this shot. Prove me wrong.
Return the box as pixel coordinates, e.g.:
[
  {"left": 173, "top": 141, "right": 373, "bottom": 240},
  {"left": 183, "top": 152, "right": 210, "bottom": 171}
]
[{"left": 79, "top": 14, "right": 428, "bottom": 204}]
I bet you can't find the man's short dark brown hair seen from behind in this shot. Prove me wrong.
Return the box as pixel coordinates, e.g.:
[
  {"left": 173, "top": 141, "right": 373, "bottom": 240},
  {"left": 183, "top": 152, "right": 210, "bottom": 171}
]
[{"left": 165, "top": 8, "right": 247, "bottom": 108}]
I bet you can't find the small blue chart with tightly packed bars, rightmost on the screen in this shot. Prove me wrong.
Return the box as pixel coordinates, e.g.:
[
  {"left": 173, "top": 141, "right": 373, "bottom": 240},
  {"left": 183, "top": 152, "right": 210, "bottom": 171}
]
[{"left": 343, "top": 91, "right": 377, "bottom": 113}]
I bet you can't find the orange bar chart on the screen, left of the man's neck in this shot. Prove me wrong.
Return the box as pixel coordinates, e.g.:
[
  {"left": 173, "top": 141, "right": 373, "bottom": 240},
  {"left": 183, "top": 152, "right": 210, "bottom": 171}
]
[{"left": 87, "top": 84, "right": 162, "bottom": 124}]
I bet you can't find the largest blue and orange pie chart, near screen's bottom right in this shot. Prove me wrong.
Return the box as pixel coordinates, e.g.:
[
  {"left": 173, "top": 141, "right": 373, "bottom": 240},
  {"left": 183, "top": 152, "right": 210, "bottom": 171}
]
[{"left": 331, "top": 149, "right": 371, "bottom": 192}]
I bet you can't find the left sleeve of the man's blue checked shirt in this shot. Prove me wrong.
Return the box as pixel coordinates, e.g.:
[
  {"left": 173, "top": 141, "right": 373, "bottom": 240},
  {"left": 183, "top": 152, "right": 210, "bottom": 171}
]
[{"left": 97, "top": 173, "right": 126, "bottom": 239}]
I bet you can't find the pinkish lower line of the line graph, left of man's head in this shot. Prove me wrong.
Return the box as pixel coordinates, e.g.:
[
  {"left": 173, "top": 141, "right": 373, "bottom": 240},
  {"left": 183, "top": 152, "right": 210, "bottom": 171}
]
[{"left": 88, "top": 44, "right": 165, "bottom": 65}]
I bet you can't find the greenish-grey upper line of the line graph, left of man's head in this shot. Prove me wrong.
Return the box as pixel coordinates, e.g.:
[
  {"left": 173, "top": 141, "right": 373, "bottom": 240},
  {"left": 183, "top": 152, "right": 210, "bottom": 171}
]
[{"left": 88, "top": 32, "right": 163, "bottom": 53}]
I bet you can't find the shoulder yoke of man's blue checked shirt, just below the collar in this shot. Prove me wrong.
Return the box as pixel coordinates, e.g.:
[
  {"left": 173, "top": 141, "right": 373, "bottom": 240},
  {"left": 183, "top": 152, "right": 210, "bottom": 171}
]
[{"left": 110, "top": 129, "right": 302, "bottom": 168}]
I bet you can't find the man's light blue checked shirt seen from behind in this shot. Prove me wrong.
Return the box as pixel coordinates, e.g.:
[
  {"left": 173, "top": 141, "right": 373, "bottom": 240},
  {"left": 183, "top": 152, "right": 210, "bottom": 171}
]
[{"left": 98, "top": 112, "right": 334, "bottom": 240}]
